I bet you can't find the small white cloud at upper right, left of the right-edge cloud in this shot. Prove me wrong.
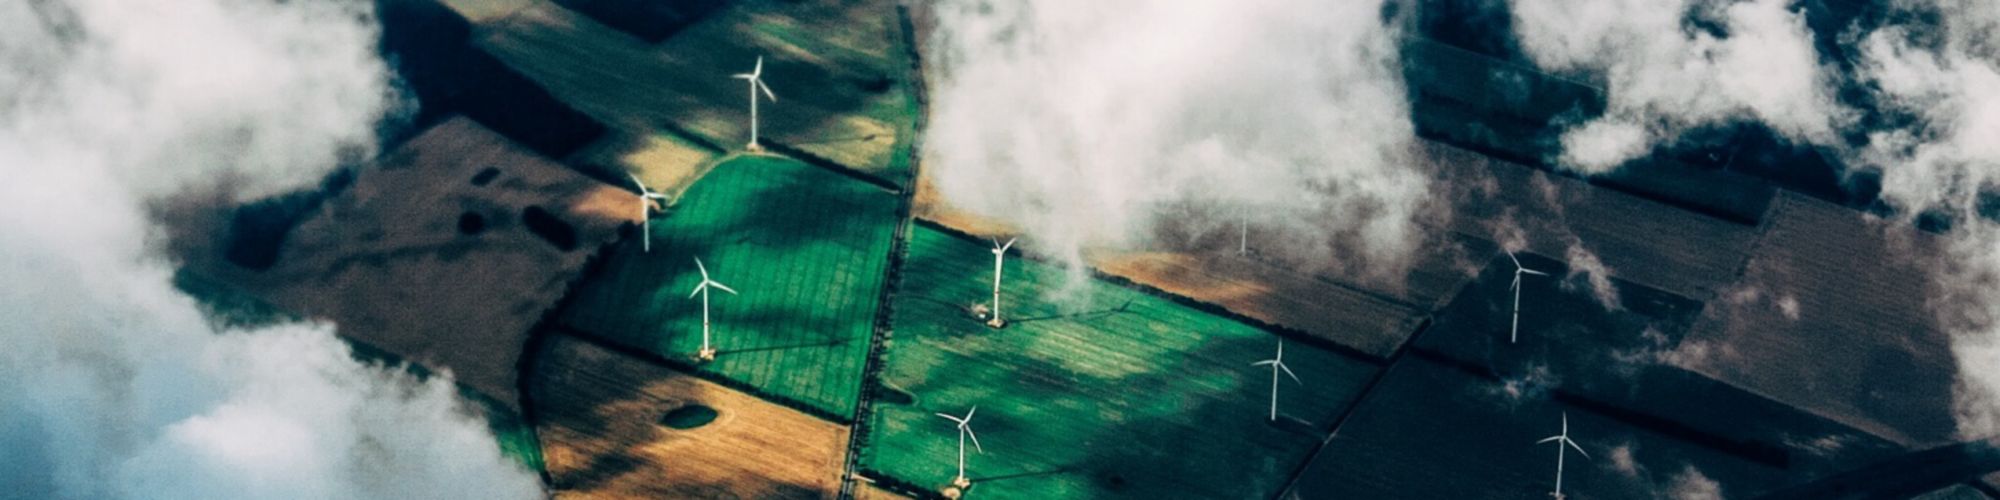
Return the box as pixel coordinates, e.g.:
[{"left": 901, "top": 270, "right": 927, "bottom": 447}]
[{"left": 1512, "top": 0, "right": 1852, "bottom": 172}]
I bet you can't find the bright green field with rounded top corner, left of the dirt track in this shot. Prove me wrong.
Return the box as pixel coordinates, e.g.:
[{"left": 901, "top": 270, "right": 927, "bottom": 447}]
[{"left": 562, "top": 156, "right": 896, "bottom": 416}]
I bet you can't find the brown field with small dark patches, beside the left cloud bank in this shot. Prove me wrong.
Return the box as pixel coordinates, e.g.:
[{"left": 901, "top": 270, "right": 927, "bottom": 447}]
[{"left": 186, "top": 118, "right": 638, "bottom": 408}]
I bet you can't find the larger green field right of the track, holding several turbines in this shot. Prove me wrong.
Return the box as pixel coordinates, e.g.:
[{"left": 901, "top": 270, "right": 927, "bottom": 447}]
[{"left": 862, "top": 226, "right": 1376, "bottom": 498}]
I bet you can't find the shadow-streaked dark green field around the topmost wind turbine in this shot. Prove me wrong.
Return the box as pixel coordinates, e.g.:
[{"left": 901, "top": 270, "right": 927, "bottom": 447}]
[{"left": 476, "top": 0, "right": 918, "bottom": 186}]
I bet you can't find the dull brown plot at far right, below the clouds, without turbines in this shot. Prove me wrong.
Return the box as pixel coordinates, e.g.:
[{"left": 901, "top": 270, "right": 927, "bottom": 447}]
[{"left": 1684, "top": 192, "right": 1956, "bottom": 446}]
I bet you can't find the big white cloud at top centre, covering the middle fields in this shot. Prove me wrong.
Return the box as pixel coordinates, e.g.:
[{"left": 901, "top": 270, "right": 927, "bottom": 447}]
[{"left": 926, "top": 0, "right": 1430, "bottom": 282}]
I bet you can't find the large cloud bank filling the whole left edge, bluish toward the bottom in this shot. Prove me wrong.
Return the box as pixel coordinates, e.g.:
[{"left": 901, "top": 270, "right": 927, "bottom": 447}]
[{"left": 0, "top": 0, "right": 540, "bottom": 498}]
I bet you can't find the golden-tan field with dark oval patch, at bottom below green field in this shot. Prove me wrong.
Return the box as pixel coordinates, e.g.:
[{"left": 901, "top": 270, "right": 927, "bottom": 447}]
[{"left": 528, "top": 336, "right": 848, "bottom": 498}]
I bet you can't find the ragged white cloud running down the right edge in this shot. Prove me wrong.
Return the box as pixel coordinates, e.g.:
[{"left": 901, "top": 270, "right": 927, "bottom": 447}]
[{"left": 1850, "top": 0, "right": 2000, "bottom": 438}]
